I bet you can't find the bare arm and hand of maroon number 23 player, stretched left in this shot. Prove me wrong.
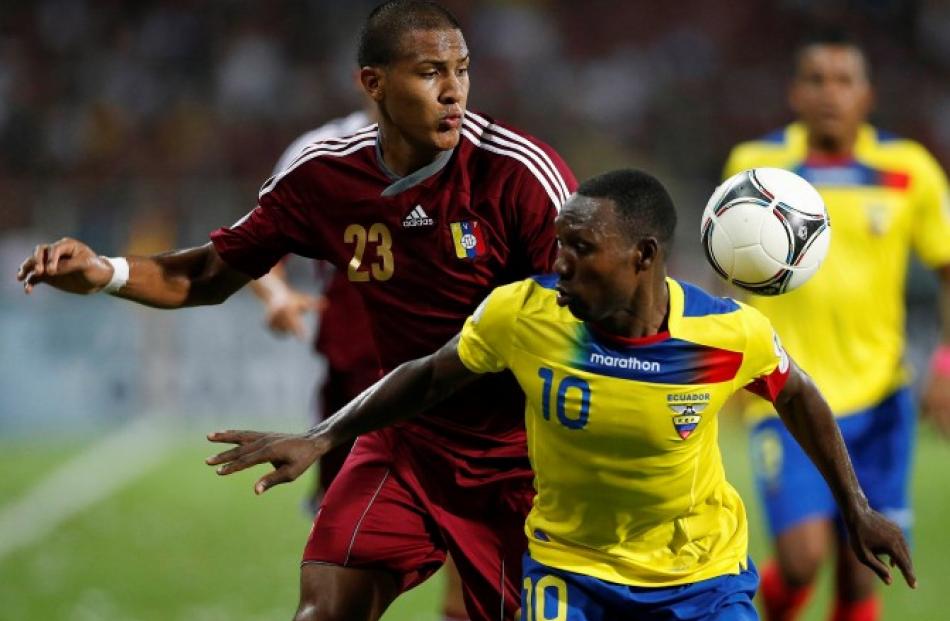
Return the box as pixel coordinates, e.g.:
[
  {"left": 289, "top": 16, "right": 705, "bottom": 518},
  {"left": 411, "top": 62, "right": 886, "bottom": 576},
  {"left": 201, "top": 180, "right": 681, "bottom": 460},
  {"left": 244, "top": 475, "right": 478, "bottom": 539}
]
[{"left": 17, "top": 237, "right": 250, "bottom": 308}]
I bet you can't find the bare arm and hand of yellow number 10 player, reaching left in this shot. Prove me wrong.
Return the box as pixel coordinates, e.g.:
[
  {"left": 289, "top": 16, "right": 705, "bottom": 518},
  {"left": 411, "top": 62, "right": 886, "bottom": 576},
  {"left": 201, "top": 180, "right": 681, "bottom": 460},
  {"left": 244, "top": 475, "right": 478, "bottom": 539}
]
[{"left": 205, "top": 336, "right": 478, "bottom": 494}]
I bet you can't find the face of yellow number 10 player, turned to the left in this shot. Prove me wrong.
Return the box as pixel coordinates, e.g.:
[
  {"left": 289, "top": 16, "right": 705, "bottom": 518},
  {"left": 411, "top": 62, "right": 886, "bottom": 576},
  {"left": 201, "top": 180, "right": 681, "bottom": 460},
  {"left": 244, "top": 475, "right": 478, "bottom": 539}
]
[{"left": 554, "top": 194, "right": 637, "bottom": 323}]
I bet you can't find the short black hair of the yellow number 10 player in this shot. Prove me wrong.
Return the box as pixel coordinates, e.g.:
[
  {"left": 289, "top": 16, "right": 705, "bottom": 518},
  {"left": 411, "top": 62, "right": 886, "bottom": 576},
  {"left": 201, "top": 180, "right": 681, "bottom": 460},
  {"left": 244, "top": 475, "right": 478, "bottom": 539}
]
[{"left": 577, "top": 168, "right": 676, "bottom": 251}]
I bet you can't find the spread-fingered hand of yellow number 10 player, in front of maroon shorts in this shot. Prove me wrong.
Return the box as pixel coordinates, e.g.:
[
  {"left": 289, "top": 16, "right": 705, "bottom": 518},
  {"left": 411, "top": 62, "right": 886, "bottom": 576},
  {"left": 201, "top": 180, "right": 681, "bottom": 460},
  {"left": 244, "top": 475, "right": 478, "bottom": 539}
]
[{"left": 205, "top": 430, "right": 327, "bottom": 494}]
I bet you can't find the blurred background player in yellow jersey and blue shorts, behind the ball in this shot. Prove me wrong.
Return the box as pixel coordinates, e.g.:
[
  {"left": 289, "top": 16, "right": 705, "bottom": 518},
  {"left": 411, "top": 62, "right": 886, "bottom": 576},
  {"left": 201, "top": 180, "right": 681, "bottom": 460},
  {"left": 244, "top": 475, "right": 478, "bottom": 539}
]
[{"left": 725, "top": 34, "right": 950, "bottom": 621}]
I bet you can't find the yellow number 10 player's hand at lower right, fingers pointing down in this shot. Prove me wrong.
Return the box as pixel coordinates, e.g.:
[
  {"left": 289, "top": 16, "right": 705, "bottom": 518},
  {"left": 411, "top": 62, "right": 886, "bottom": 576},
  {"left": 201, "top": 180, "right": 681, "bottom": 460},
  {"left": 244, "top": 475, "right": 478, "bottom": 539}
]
[{"left": 847, "top": 508, "right": 917, "bottom": 589}]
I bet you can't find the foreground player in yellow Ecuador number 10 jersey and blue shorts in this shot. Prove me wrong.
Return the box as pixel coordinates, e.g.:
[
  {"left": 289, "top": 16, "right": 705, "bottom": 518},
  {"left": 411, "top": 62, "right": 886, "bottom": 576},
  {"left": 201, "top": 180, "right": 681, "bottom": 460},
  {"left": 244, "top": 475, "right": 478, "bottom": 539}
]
[{"left": 208, "top": 170, "right": 915, "bottom": 621}]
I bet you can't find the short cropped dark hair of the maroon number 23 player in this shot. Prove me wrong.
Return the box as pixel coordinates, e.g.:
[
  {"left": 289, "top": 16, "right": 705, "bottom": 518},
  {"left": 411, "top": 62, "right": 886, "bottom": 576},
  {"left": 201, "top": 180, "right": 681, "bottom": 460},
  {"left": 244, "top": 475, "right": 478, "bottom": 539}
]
[{"left": 356, "top": 0, "right": 462, "bottom": 67}]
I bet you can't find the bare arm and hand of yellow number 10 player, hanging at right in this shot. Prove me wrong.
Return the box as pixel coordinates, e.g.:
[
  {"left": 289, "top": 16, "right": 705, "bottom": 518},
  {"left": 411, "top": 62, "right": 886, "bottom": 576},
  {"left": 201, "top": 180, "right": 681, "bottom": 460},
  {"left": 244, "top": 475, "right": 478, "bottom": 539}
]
[{"left": 775, "top": 362, "right": 917, "bottom": 588}]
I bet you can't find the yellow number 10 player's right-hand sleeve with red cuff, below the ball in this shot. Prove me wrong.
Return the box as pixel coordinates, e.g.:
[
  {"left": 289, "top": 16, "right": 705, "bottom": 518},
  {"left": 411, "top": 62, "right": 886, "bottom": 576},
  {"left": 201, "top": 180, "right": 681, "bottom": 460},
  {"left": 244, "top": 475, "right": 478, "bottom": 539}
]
[{"left": 740, "top": 304, "right": 791, "bottom": 401}]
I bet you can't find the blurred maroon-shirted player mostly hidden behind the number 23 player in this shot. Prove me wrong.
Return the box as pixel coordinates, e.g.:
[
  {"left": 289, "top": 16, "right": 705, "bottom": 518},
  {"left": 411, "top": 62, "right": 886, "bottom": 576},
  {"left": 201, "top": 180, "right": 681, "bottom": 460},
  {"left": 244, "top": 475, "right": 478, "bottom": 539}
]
[{"left": 250, "top": 101, "right": 468, "bottom": 621}]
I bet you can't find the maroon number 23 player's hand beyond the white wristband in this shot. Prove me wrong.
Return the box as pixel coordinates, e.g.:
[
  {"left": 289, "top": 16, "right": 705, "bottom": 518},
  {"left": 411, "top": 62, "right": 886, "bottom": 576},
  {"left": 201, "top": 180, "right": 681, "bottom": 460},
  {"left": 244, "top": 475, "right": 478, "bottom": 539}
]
[{"left": 16, "top": 237, "right": 112, "bottom": 294}]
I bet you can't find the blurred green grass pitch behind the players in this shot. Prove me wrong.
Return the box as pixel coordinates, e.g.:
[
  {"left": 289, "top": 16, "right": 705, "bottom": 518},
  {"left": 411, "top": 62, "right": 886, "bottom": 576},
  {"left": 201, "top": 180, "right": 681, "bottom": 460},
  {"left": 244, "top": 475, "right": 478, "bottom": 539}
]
[{"left": 0, "top": 418, "right": 950, "bottom": 621}]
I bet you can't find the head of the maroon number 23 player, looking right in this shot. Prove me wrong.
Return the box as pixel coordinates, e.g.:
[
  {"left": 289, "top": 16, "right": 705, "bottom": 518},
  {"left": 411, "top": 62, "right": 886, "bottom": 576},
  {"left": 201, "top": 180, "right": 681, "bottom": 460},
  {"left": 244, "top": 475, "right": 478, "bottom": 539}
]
[{"left": 358, "top": 0, "right": 469, "bottom": 151}]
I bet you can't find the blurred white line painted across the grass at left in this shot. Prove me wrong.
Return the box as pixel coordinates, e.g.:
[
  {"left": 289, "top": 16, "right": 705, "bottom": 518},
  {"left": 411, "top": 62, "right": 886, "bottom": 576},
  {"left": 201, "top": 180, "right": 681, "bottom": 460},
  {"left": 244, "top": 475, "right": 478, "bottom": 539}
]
[{"left": 0, "top": 416, "right": 173, "bottom": 560}]
